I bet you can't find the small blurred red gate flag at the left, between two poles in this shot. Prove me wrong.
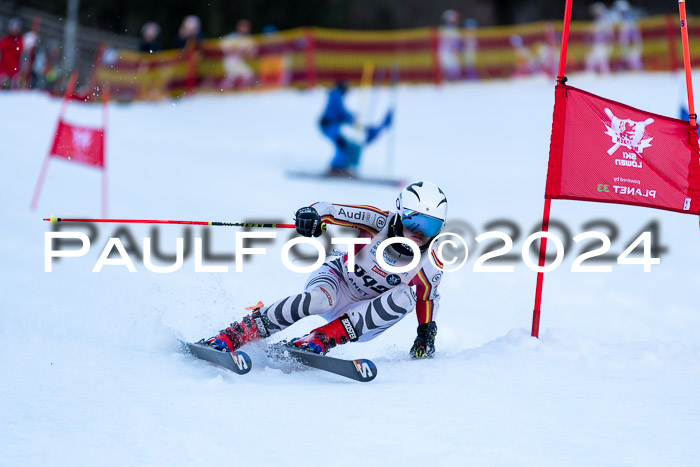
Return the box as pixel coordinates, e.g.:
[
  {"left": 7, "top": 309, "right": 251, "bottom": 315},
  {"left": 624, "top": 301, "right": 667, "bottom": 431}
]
[{"left": 49, "top": 120, "right": 104, "bottom": 168}]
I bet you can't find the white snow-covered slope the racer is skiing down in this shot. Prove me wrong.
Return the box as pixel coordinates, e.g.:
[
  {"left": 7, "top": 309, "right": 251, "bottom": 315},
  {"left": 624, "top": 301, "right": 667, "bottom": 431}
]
[{"left": 0, "top": 74, "right": 700, "bottom": 466}]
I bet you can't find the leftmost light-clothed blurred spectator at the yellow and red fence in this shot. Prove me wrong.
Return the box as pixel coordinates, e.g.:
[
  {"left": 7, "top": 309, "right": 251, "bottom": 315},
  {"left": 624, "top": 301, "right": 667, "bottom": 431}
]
[{"left": 221, "top": 19, "right": 258, "bottom": 89}]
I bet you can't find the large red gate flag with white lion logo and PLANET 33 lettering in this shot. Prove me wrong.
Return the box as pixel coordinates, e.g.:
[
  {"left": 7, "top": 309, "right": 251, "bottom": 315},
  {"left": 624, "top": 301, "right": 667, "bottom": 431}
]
[{"left": 545, "top": 84, "right": 700, "bottom": 214}]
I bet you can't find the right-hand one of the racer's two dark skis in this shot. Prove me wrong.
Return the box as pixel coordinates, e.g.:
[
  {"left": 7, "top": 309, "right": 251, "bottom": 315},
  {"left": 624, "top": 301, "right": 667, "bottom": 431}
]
[{"left": 268, "top": 342, "right": 377, "bottom": 383}]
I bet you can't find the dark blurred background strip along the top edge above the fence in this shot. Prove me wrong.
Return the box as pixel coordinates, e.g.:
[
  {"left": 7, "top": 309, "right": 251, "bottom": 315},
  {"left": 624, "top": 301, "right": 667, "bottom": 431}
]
[{"left": 5, "top": 0, "right": 691, "bottom": 47}]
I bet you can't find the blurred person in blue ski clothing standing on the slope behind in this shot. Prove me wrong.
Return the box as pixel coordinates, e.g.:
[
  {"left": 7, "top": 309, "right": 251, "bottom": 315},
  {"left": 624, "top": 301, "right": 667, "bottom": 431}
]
[{"left": 319, "top": 81, "right": 392, "bottom": 176}]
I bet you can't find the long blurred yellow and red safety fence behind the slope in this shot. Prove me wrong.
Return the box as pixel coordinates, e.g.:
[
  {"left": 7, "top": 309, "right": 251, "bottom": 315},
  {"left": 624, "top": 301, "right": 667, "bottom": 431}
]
[{"left": 94, "top": 15, "right": 700, "bottom": 100}]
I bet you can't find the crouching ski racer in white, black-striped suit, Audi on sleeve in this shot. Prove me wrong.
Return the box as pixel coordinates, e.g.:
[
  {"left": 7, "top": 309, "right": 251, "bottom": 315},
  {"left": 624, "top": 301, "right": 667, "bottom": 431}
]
[{"left": 200, "top": 181, "right": 447, "bottom": 358}]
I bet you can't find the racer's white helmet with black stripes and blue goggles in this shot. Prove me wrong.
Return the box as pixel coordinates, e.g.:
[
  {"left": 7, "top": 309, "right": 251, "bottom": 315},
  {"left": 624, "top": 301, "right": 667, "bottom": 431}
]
[{"left": 396, "top": 181, "right": 447, "bottom": 238}]
